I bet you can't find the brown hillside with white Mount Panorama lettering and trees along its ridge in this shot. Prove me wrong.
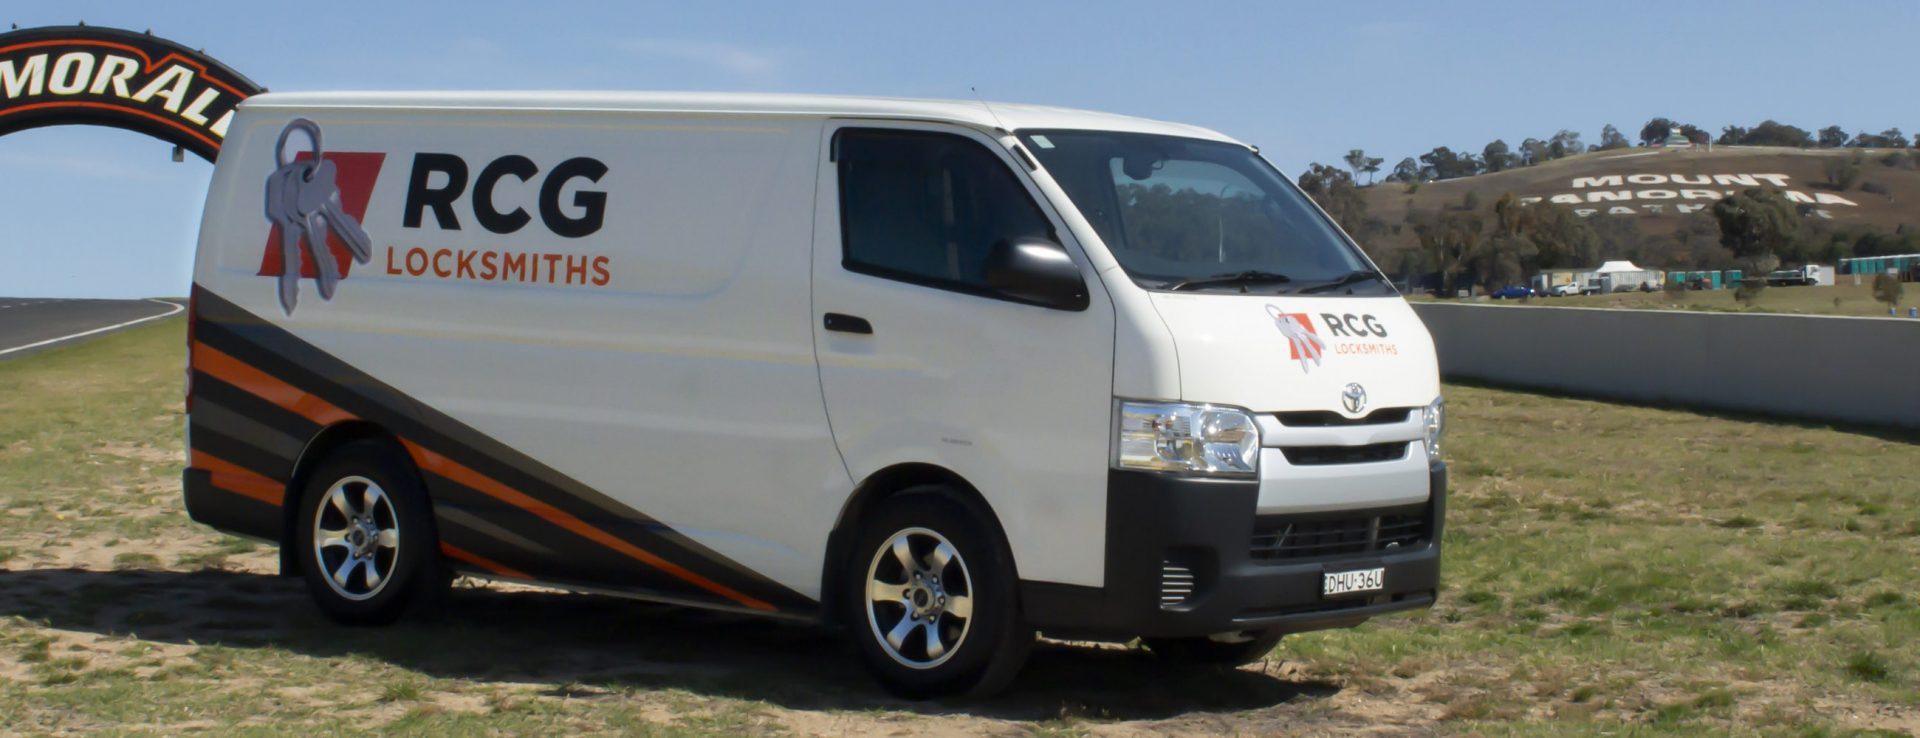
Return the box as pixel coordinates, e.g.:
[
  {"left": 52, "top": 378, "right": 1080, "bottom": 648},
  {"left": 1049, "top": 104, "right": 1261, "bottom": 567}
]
[{"left": 1361, "top": 146, "right": 1920, "bottom": 258}]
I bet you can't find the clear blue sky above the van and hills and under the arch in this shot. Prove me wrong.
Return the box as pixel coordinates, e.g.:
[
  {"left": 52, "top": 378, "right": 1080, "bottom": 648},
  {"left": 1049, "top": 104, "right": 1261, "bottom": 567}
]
[{"left": 0, "top": 0, "right": 1920, "bottom": 298}]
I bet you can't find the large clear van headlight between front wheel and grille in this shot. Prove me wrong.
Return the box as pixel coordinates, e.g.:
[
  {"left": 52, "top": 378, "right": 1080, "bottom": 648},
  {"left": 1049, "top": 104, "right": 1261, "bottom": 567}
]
[{"left": 1114, "top": 402, "right": 1260, "bottom": 477}]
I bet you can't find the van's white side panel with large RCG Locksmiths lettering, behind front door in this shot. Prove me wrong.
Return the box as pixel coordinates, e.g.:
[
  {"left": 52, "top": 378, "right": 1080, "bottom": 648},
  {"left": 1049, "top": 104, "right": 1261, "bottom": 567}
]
[{"left": 196, "top": 108, "right": 851, "bottom": 613}]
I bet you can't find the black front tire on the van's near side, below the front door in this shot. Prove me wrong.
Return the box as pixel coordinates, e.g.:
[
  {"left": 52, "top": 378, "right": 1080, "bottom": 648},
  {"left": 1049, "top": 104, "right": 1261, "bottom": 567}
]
[{"left": 841, "top": 486, "right": 1035, "bottom": 700}]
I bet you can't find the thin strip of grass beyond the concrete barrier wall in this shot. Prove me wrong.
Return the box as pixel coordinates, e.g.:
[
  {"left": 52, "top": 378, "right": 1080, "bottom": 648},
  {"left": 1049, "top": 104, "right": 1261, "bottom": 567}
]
[{"left": 1407, "top": 277, "right": 1920, "bottom": 319}]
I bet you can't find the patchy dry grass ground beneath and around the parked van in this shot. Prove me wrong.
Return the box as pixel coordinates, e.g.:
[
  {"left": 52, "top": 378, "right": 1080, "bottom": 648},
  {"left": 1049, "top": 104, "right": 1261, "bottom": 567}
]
[{"left": 0, "top": 319, "right": 1920, "bottom": 736}]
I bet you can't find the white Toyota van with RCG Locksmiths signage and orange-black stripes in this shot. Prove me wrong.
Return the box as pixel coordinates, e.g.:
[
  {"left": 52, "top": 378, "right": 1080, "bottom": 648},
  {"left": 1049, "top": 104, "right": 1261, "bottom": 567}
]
[{"left": 184, "top": 92, "right": 1446, "bottom": 696}]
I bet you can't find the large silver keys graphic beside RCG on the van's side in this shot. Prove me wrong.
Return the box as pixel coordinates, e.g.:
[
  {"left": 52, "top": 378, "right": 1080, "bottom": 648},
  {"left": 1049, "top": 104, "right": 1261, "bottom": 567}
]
[{"left": 267, "top": 117, "right": 372, "bottom": 315}]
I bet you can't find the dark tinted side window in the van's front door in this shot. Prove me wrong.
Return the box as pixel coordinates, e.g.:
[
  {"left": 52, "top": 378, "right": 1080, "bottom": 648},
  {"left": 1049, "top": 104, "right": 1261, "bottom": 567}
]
[{"left": 835, "top": 129, "right": 1056, "bottom": 292}]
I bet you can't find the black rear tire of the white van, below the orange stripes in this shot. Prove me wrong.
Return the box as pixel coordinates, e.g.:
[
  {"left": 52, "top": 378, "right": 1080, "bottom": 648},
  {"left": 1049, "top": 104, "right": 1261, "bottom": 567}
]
[{"left": 292, "top": 440, "right": 451, "bottom": 625}]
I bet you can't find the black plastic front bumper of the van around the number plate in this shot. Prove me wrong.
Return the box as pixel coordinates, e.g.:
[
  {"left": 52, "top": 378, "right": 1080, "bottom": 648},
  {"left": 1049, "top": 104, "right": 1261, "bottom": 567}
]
[{"left": 1021, "top": 465, "right": 1446, "bottom": 640}]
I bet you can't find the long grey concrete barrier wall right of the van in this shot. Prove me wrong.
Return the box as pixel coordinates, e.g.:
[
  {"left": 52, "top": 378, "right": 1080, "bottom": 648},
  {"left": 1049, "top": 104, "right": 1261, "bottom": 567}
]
[{"left": 1413, "top": 302, "right": 1920, "bottom": 429}]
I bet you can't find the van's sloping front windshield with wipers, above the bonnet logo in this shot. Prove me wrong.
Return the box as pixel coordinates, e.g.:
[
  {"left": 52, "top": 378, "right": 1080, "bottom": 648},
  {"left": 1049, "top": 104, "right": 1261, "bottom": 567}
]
[{"left": 1020, "top": 131, "right": 1394, "bottom": 294}]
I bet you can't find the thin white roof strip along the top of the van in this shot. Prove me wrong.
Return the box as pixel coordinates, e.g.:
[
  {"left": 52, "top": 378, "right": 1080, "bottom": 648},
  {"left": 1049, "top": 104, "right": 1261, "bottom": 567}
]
[{"left": 242, "top": 90, "right": 1235, "bottom": 142}]
